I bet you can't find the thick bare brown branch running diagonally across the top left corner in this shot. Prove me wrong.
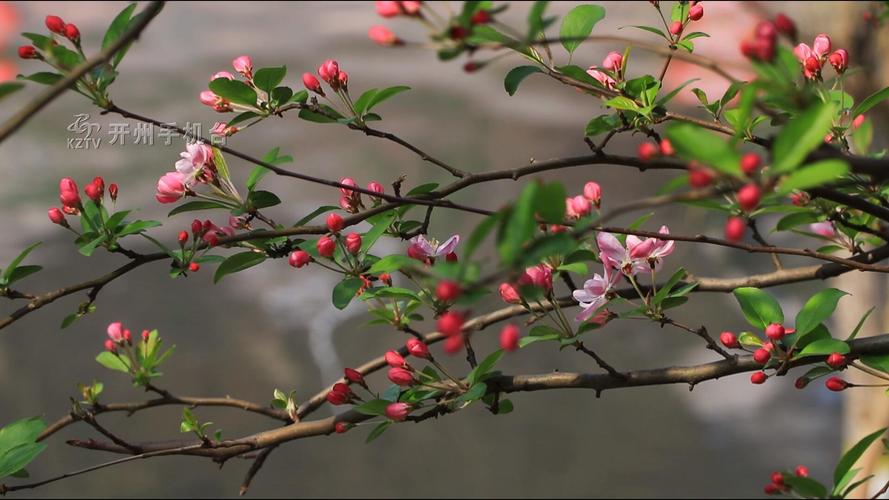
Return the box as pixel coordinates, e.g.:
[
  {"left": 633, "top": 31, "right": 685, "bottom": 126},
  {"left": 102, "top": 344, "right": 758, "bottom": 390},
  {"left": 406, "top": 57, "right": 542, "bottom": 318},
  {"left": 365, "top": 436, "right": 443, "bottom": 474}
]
[{"left": 0, "top": 1, "right": 164, "bottom": 143}]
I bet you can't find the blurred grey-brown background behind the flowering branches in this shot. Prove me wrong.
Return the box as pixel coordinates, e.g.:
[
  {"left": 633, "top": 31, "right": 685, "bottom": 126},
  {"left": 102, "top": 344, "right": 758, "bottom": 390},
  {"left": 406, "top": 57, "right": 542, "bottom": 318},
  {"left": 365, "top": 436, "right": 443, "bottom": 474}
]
[{"left": 0, "top": 2, "right": 889, "bottom": 498}]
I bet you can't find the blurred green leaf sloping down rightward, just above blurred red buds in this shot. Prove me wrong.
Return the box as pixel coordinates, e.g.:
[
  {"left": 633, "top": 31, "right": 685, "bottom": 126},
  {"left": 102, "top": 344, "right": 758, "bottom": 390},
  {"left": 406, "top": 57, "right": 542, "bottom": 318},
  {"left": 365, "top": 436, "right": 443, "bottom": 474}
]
[{"left": 667, "top": 123, "right": 741, "bottom": 177}]
